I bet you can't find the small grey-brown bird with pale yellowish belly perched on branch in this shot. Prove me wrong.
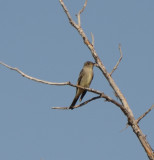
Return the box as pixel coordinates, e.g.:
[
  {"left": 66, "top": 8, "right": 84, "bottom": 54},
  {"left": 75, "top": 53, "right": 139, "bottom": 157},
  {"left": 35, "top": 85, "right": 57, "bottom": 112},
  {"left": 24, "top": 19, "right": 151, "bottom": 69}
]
[{"left": 69, "top": 61, "right": 95, "bottom": 109}]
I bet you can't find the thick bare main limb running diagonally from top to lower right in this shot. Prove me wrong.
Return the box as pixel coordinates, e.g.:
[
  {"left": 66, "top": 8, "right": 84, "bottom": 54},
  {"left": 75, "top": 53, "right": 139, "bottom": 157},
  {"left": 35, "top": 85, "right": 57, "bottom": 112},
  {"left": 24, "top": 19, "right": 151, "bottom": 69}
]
[{"left": 59, "top": 0, "right": 154, "bottom": 160}]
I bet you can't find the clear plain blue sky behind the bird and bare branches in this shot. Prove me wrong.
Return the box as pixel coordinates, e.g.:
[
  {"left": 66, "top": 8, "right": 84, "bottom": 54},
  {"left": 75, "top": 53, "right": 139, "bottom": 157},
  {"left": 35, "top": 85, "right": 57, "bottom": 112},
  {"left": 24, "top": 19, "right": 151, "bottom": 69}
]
[{"left": 0, "top": 0, "right": 154, "bottom": 160}]
